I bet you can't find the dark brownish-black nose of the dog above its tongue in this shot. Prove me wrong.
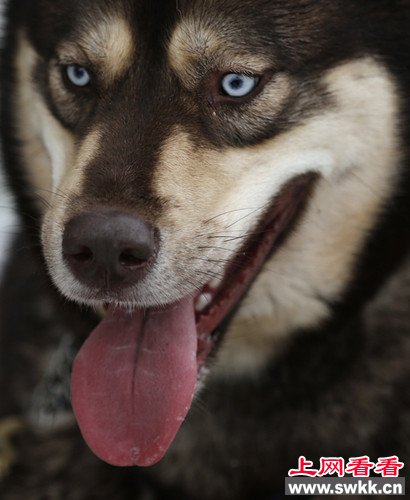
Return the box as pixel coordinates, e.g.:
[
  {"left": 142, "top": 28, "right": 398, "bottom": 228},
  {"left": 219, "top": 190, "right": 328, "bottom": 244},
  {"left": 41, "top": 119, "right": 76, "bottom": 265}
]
[{"left": 63, "top": 211, "right": 156, "bottom": 289}]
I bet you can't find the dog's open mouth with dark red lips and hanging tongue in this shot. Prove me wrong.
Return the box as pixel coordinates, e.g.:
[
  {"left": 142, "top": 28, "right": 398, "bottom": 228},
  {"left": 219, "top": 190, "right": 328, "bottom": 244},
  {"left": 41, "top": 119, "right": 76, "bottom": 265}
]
[{"left": 71, "top": 174, "right": 315, "bottom": 466}]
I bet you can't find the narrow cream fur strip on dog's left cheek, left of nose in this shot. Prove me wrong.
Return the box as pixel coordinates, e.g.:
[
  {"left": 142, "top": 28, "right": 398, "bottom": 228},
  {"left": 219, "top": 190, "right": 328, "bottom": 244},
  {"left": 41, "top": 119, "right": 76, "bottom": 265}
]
[{"left": 14, "top": 33, "right": 106, "bottom": 296}]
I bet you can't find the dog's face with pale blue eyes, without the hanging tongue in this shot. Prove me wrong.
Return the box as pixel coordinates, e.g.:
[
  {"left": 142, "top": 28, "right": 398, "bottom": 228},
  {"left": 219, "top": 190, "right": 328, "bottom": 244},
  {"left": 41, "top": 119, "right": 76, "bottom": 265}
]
[{"left": 8, "top": 0, "right": 399, "bottom": 466}]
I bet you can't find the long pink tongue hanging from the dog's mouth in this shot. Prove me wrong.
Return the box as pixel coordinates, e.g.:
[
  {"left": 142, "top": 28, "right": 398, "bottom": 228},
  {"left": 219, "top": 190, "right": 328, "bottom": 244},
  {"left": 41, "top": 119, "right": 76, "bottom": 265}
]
[{"left": 71, "top": 298, "right": 197, "bottom": 466}]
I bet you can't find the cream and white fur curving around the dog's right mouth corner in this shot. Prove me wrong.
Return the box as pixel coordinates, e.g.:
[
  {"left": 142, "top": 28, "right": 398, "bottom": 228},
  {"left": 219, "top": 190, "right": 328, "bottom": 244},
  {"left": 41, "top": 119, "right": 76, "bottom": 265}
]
[{"left": 155, "top": 58, "right": 401, "bottom": 375}]
